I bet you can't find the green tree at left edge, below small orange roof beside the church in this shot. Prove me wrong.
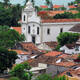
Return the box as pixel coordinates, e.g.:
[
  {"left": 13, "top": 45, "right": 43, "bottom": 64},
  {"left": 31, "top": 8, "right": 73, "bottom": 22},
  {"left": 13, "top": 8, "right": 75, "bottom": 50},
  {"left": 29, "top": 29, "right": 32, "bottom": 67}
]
[{"left": 0, "top": 29, "right": 24, "bottom": 48}]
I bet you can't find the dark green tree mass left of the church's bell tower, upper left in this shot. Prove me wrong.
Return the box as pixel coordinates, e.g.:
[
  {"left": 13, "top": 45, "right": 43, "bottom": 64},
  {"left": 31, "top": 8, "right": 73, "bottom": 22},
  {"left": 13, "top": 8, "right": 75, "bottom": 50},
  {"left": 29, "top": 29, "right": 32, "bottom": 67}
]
[{"left": 0, "top": 3, "right": 22, "bottom": 26}]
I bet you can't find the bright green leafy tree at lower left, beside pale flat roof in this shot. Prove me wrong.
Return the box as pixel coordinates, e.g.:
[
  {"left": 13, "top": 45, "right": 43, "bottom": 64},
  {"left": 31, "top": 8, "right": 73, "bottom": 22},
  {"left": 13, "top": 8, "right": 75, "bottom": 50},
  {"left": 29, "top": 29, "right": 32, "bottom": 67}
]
[{"left": 10, "top": 62, "right": 32, "bottom": 80}]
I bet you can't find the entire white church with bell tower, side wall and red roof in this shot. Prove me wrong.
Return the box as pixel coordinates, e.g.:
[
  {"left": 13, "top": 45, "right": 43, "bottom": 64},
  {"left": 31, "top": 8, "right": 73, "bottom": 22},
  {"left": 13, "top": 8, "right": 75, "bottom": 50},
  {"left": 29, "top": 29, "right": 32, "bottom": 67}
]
[{"left": 21, "top": 1, "right": 80, "bottom": 44}]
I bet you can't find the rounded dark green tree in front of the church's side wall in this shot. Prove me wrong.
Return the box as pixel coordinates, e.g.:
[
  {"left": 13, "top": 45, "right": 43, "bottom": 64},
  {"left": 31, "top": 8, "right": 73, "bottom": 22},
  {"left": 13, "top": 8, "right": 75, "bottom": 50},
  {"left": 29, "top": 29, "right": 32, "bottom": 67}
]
[{"left": 57, "top": 32, "right": 80, "bottom": 46}]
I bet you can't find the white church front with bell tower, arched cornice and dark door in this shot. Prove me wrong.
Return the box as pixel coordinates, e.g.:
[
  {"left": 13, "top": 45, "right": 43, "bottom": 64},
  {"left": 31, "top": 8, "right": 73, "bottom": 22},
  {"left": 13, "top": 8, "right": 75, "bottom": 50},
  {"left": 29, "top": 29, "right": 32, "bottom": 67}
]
[{"left": 21, "top": 0, "right": 41, "bottom": 44}]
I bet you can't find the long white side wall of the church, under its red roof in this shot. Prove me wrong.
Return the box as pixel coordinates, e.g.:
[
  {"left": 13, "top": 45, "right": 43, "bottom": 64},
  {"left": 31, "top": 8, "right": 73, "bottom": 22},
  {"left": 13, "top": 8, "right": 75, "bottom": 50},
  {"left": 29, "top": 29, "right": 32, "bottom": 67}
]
[{"left": 42, "top": 22, "right": 80, "bottom": 42}]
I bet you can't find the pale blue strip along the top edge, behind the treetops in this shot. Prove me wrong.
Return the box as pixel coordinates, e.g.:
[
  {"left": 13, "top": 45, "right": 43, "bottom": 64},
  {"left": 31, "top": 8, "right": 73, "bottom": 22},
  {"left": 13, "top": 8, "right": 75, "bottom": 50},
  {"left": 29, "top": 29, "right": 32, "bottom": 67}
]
[{"left": 0, "top": 0, "right": 74, "bottom": 5}]
